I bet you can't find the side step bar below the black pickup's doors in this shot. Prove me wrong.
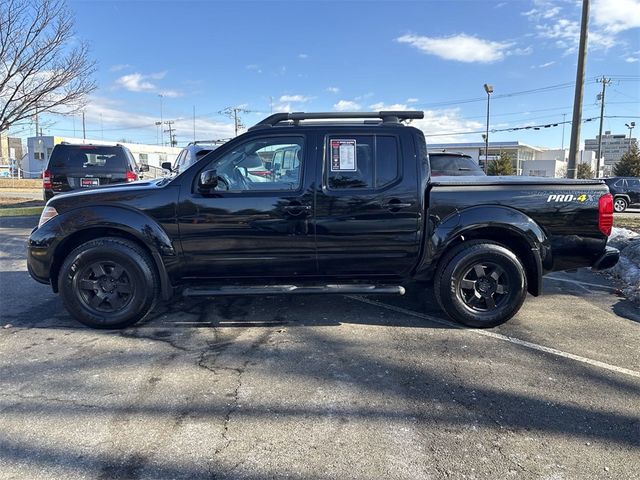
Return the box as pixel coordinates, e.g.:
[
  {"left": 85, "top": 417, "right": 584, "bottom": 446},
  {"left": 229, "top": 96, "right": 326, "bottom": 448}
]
[{"left": 182, "top": 285, "right": 405, "bottom": 297}]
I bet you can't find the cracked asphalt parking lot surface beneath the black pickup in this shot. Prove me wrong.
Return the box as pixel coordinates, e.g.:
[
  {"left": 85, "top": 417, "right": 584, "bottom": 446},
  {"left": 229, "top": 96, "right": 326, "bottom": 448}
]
[{"left": 0, "top": 218, "right": 640, "bottom": 479}]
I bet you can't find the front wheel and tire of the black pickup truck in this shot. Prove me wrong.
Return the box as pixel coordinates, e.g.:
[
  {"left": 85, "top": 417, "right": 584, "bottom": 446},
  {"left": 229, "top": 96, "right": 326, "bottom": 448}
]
[{"left": 58, "top": 237, "right": 160, "bottom": 329}]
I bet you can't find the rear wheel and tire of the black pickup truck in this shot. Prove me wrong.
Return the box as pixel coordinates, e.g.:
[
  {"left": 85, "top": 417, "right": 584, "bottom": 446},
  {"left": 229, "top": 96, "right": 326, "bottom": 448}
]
[{"left": 434, "top": 240, "right": 527, "bottom": 328}]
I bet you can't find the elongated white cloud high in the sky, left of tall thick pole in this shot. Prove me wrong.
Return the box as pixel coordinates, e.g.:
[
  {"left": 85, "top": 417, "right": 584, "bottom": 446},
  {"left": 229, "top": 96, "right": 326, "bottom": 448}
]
[{"left": 396, "top": 33, "right": 514, "bottom": 63}]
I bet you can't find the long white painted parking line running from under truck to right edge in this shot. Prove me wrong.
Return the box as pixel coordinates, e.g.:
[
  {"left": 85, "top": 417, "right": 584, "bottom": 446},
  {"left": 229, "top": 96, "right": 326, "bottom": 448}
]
[{"left": 345, "top": 295, "right": 640, "bottom": 378}]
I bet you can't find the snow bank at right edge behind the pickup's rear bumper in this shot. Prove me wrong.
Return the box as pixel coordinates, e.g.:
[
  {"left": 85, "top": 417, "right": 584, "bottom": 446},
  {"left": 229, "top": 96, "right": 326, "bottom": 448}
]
[{"left": 607, "top": 227, "right": 640, "bottom": 303}]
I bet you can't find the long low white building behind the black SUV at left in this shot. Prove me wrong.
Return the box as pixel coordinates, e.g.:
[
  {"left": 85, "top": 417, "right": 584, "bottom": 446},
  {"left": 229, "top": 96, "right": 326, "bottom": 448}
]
[{"left": 20, "top": 136, "right": 182, "bottom": 178}]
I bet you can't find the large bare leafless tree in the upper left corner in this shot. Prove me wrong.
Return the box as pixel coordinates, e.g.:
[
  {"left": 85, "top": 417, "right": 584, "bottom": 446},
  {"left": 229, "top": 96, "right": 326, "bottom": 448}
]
[{"left": 0, "top": 0, "right": 96, "bottom": 131}]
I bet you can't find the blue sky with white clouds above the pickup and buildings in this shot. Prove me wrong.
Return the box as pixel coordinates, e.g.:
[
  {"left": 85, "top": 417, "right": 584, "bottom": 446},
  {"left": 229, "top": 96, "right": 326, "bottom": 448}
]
[{"left": 16, "top": 0, "right": 640, "bottom": 147}]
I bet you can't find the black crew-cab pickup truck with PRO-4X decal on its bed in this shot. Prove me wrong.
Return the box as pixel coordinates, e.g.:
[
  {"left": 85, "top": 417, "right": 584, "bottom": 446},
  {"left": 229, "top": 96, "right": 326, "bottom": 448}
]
[{"left": 28, "top": 111, "right": 618, "bottom": 328}]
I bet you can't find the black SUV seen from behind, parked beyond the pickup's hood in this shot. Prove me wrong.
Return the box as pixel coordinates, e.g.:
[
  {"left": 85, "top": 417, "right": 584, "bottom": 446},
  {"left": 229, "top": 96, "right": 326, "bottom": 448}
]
[{"left": 42, "top": 143, "right": 149, "bottom": 201}]
